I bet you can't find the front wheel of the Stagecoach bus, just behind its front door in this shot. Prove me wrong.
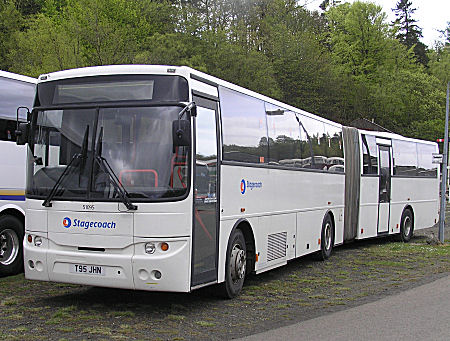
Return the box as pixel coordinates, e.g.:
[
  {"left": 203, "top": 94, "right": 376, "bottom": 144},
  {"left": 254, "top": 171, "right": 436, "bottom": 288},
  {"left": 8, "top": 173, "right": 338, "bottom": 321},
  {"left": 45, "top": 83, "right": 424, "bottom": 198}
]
[{"left": 222, "top": 229, "right": 247, "bottom": 298}]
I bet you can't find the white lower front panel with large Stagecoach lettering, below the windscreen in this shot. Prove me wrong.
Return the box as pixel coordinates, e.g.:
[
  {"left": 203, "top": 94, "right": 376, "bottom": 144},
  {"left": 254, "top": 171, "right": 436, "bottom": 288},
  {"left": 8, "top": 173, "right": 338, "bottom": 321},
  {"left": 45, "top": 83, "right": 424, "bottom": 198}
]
[{"left": 24, "top": 199, "right": 192, "bottom": 292}]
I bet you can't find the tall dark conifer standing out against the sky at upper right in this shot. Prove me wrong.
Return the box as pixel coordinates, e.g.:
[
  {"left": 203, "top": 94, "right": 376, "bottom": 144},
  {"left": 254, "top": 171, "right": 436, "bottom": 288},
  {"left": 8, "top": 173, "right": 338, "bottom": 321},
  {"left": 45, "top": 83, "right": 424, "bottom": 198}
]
[{"left": 393, "top": 0, "right": 429, "bottom": 66}]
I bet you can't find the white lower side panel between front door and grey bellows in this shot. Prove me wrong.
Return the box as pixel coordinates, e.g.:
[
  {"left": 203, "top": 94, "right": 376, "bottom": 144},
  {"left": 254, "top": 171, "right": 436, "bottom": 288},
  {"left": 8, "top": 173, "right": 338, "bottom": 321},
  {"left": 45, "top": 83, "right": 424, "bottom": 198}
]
[{"left": 219, "top": 165, "right": 345, "bottom": 281}]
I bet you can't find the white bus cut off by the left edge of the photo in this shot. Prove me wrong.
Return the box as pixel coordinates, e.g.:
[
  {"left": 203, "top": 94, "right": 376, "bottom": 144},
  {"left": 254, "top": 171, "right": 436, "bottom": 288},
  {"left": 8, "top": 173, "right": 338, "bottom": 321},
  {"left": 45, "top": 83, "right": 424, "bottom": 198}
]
[{"left": 0, "top": 71, "right": 37, "bottom": 276}]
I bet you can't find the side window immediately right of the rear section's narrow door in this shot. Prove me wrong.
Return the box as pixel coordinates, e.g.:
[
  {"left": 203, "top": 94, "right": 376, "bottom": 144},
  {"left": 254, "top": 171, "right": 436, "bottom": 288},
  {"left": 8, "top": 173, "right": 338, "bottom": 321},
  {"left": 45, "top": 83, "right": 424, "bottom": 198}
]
[{"left": 392, "top": 140, "right": 417, "bottom": 176}]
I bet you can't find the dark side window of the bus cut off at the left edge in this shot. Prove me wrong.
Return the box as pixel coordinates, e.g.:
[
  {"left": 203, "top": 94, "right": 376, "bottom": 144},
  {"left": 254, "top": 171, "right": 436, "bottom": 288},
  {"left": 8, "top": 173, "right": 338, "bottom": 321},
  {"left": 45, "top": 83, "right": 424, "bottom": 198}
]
[{"left": 0, "top": 77, "right": 36, "bottom": 120}]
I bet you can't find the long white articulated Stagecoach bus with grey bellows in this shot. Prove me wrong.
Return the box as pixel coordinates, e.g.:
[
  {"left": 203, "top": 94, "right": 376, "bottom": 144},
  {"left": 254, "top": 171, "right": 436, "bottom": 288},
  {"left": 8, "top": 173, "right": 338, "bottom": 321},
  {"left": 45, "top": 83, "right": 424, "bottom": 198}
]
[{"left": 18, "top": 65, "right": 439, "bottom": 298}]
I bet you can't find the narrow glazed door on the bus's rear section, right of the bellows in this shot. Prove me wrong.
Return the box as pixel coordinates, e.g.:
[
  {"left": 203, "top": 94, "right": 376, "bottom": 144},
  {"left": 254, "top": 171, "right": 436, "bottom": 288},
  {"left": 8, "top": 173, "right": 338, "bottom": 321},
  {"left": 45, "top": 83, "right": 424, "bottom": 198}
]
[{"left": 378, "top": 145, "right": 392, "bottom": 234}]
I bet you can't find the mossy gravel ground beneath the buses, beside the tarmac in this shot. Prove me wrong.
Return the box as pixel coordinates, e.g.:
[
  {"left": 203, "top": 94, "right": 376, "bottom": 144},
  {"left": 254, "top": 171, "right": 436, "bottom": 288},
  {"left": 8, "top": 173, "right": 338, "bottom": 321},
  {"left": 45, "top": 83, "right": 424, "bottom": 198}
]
[{"left": 0, "top": 227, "right": 450, "bottom": 340}]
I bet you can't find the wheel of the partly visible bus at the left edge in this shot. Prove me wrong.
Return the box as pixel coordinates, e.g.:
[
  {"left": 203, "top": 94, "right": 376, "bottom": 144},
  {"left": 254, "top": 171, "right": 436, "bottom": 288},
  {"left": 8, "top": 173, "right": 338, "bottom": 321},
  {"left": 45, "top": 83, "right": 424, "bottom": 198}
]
[{"left": 0, "top": 215, "right": 24, "bottom": 276}]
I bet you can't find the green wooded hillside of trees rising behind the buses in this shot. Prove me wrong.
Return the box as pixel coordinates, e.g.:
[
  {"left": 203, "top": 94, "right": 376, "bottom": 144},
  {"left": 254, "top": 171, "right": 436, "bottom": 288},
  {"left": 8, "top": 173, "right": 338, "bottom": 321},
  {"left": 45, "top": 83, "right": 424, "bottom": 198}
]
[{"left": 0, "top": 0, "right": 450, "bottom": 141}]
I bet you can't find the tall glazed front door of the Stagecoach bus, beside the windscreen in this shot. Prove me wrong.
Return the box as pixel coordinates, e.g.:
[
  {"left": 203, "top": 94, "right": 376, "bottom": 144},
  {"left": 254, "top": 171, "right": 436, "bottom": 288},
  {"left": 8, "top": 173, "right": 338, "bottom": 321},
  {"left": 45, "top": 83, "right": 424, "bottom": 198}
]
[{"left": 191, "top": 96, "right": 219, "bottom": 287}]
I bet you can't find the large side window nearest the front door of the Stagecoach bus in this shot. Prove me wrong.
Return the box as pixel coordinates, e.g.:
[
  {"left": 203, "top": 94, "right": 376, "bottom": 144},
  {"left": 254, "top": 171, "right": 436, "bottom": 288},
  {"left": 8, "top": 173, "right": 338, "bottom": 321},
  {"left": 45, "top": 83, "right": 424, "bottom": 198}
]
[{"left": 220, "top": 87, "right": 268, "bottom": 163}]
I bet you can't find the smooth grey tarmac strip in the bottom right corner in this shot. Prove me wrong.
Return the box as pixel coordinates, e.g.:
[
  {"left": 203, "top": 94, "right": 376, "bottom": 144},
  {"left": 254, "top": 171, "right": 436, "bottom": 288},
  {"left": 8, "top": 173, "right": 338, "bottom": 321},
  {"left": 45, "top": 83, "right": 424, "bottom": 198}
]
[{"left": 239, "top": 276, "right": 450, "bottom": 341}]
